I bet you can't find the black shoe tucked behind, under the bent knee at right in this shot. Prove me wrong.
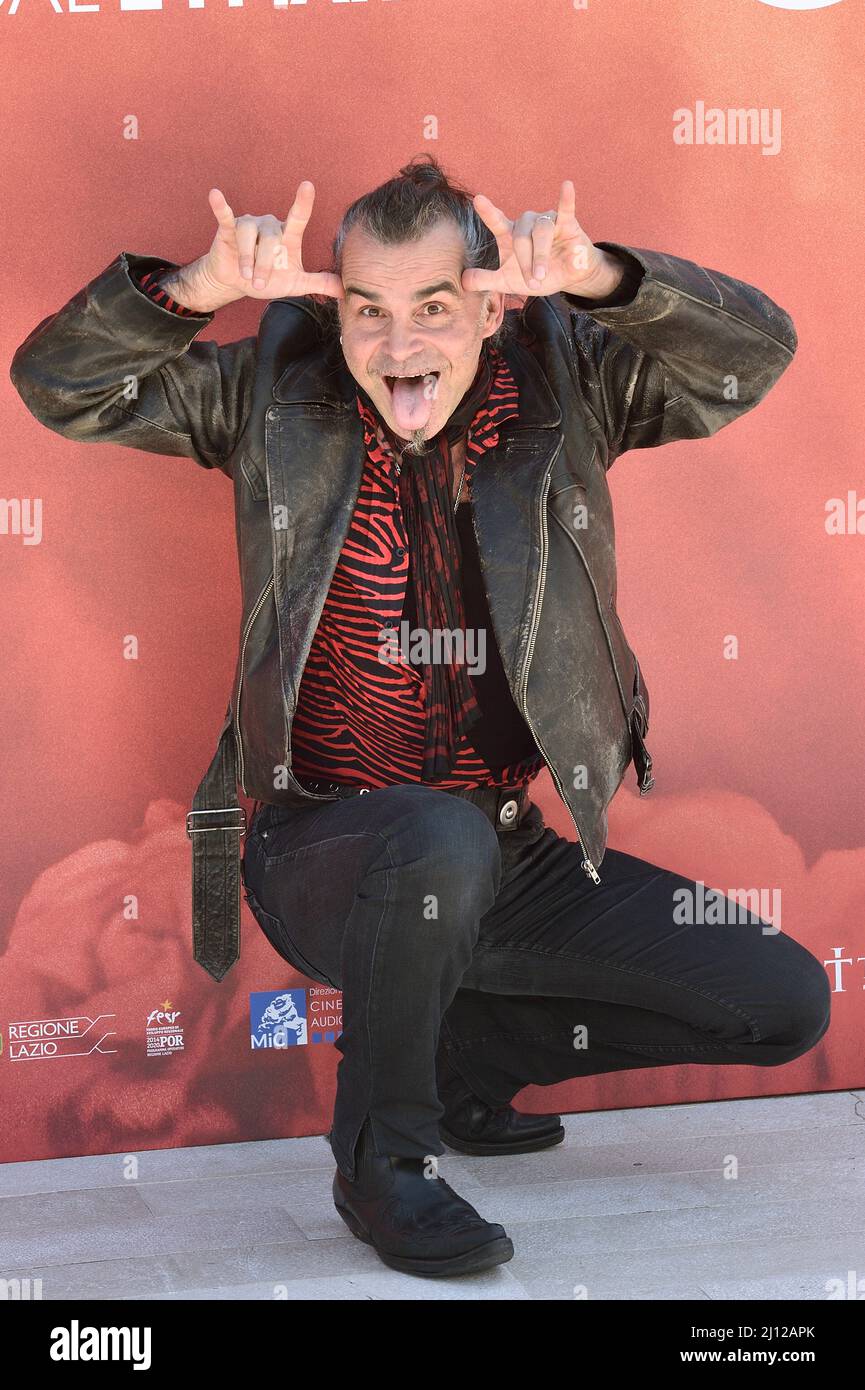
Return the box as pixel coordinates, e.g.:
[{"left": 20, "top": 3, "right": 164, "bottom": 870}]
[{"left": 437, "top": 1055, "right": 565, "bottom": 1155}]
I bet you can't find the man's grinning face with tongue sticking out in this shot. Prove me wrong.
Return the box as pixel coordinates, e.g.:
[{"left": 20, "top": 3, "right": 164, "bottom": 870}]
[{"left": 339, "top": 220, "right": 505, "bottom": 453}]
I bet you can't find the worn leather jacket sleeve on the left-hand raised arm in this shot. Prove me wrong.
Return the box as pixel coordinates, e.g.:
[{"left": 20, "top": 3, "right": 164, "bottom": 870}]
[{"left": 10, "top": 252, "right": 256, "bottom": 477}]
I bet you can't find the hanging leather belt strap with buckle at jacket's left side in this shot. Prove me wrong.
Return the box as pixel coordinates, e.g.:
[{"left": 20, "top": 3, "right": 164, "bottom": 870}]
[{"left": 186, "top": 705, "right": 246, "bottom": 980}]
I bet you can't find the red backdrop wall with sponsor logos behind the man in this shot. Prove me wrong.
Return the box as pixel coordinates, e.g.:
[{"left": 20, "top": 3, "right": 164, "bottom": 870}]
[{"left": 0, "top": 0, "right": 865, "bottom": 1161}]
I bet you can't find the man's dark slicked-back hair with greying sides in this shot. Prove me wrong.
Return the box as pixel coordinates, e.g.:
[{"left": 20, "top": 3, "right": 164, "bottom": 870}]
[{"left": 312, "top": 154, "right": 512, "bottom": 346}]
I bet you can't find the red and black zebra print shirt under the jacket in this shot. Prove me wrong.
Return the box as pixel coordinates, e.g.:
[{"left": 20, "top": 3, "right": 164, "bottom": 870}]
[{"left": 136, "top": 268, "right": 544, "bottom": 787}]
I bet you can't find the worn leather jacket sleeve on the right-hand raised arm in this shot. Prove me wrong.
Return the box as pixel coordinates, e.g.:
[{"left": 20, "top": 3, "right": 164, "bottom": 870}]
[{"left": 560, "top": 242, "right": 797, "bottom": 467}]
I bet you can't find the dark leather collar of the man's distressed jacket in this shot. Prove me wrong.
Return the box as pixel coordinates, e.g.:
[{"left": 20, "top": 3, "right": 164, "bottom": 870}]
[{"left": 269, "top": 295, "right": 562, "bottom": 432}]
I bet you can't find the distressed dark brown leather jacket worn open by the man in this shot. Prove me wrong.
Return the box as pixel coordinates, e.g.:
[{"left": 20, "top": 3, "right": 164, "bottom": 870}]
[{"left": 11, "top": 242, "right": 797, "bottom": 977}]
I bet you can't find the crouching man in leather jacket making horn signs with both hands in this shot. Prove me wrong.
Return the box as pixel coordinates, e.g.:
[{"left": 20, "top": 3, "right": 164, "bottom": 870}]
[{"left": 11, "top": 157, "right": 829, "bottom": 1275}]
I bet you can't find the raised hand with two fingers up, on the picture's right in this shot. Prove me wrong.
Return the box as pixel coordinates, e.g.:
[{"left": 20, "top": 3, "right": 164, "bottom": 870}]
[{"left": 462, "top": 179, "right": 623, "bottom": 299}]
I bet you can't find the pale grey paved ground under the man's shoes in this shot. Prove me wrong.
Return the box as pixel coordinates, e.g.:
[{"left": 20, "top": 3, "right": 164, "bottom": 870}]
[{"left": 0, "top": 1090, "right": 865, "bottom": 1300}]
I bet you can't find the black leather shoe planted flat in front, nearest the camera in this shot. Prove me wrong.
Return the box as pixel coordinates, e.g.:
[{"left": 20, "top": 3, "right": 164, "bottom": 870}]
[{"left": 334, "top": 1119, "right": 513, "bottom": 1275}]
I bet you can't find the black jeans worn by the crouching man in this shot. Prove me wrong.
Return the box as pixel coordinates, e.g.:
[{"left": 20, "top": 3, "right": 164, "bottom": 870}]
[{"left": 243, "top": 784, "right": 830, "bottom": 1179}]
